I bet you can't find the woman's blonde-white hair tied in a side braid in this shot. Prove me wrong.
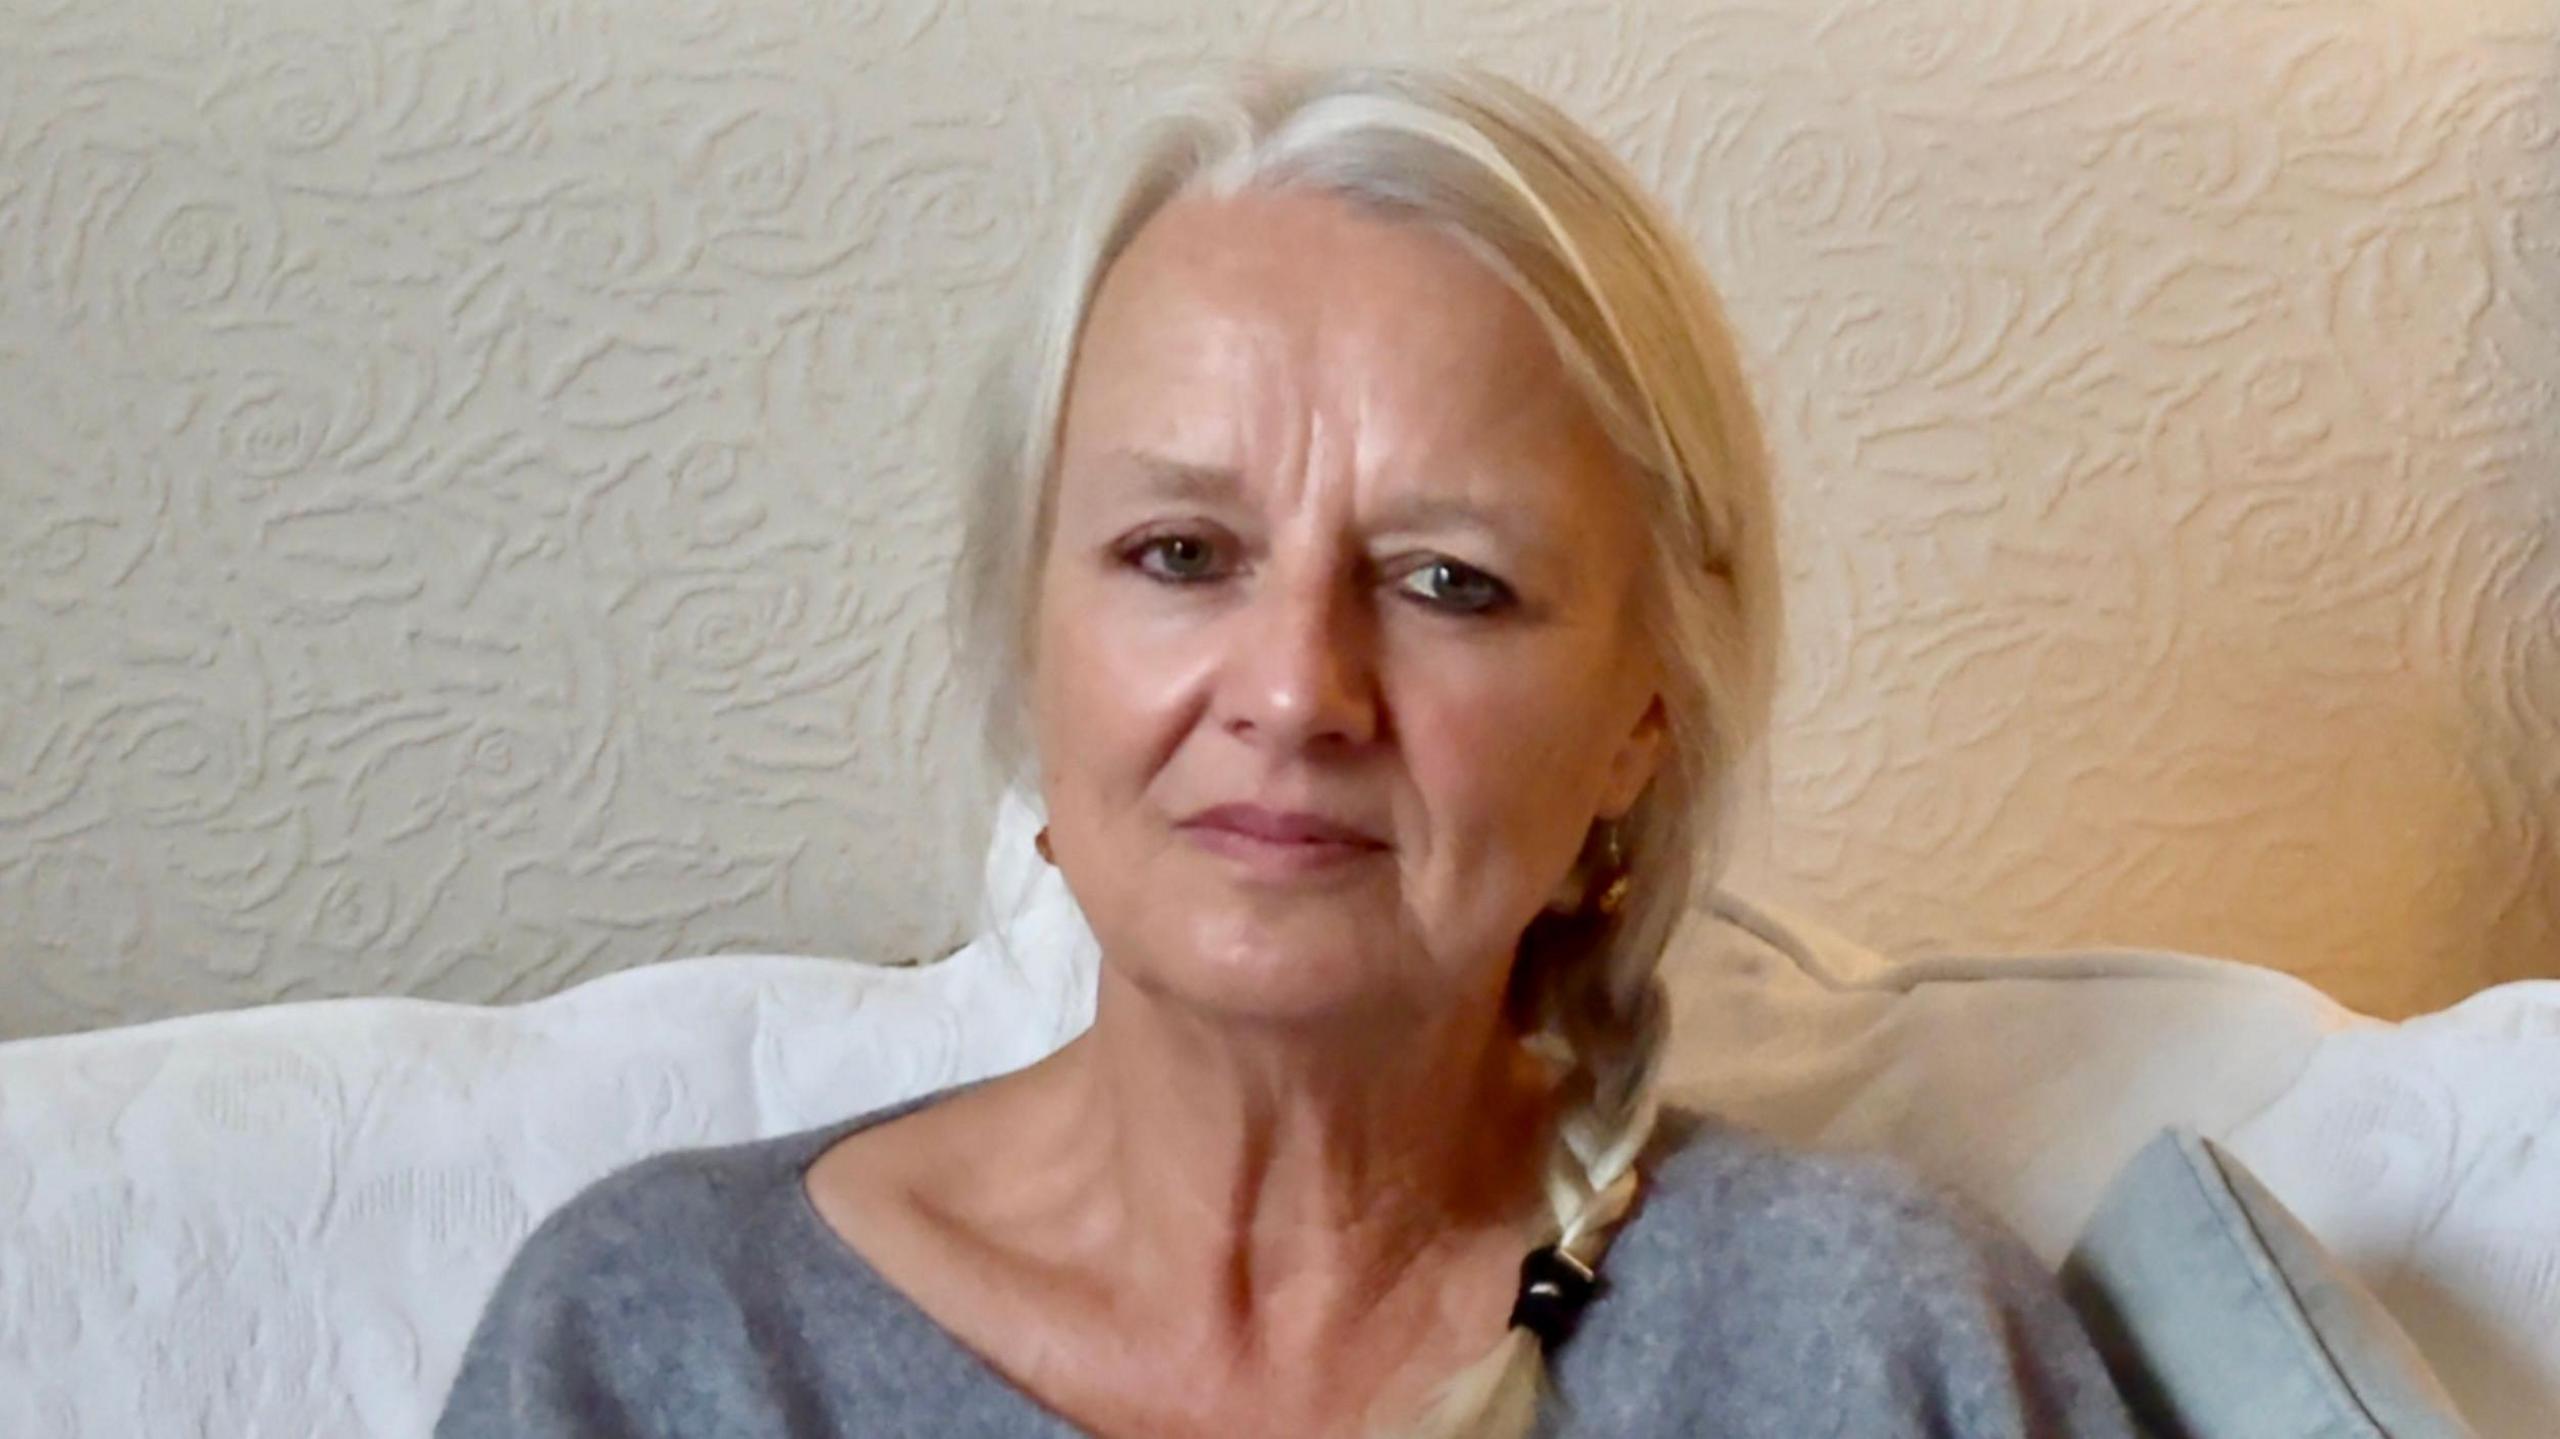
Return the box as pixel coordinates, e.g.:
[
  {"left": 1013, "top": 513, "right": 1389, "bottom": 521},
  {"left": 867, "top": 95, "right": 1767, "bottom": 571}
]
[{"left": 955, "top": 64, "right": 1779, "bottom": 1436}]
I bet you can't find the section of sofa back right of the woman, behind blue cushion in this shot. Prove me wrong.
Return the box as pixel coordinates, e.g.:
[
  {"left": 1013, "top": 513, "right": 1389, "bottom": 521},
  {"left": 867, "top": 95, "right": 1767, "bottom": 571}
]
[{"left": 1667, "top": 896, "right": 2560, "bottom": 1439}]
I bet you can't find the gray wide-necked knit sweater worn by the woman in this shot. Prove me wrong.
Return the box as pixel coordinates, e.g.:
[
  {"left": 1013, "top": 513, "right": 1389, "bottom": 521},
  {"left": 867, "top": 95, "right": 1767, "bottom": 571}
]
[{"left": 435, "top": 1096, "right": 2132, "bottom": 1439}]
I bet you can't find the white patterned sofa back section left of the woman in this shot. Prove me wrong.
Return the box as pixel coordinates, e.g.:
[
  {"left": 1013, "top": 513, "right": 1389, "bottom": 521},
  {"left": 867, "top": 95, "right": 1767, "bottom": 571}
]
[{"left": 0, "top": 788, "right": 1096, "bottom": 1439}]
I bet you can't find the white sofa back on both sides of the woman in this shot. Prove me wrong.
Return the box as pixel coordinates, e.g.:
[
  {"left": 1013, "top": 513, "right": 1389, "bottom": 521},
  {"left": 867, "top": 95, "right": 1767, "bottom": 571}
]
[{"left": 0, "top": 793, "right": 2560, "bottom": 1439}]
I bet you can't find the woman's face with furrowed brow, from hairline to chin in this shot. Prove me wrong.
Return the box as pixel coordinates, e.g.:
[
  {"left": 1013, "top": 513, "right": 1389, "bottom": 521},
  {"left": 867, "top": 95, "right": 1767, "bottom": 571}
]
[{"left": 1032, "top": 192, "right": 1661, "bottom": 1019}]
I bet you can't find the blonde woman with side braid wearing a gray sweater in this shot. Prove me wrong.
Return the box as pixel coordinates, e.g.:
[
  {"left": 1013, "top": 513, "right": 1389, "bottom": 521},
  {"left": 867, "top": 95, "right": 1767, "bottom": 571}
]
[{"left": 440, "top": 69, "right": 2127, "bottom": 1439}]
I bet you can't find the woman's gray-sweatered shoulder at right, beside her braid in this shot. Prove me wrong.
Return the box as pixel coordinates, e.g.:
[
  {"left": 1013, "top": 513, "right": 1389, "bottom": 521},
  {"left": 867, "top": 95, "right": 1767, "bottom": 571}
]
[{"left": 1590, "top": 1111, "right": 2130, "bottom": 1434}]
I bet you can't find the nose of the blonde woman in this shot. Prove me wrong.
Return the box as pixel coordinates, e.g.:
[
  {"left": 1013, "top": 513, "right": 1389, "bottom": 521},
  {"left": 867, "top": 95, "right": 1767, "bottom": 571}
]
[{"left": 1221, "top": 563, "right": 1377, "bottom": 748}]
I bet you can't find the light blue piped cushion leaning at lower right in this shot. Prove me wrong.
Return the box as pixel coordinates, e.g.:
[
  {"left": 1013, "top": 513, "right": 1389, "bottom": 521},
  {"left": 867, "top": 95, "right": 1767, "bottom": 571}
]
[{"left": 2063, "top": 1129, "right": 2470, "bottom": 1439}]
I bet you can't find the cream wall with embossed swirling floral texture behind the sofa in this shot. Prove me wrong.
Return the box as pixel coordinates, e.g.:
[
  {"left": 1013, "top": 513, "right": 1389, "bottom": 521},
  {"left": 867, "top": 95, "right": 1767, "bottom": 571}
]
[{"left": 0, "top": 0, "right": 2560, "bottom": 1034}]
